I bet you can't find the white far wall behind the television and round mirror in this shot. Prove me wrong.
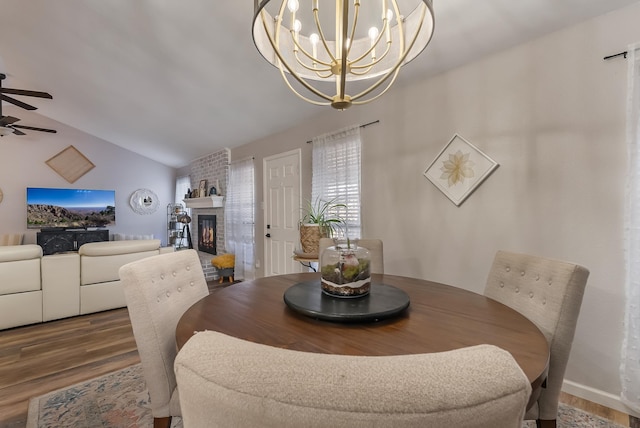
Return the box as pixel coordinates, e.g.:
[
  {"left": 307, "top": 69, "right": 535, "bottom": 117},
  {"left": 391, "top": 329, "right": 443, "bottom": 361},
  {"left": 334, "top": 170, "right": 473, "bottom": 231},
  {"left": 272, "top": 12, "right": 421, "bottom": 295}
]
[{"left": 0, "top": 108, "right": 175, "bottom": 244}]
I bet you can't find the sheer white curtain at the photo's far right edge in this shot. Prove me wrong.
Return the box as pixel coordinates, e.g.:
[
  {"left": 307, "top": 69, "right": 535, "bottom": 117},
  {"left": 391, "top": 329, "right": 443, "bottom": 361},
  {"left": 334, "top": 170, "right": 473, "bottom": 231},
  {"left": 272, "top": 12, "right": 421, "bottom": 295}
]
[{"left": 620, "top": 43, "right": 640, "bottom": 412}]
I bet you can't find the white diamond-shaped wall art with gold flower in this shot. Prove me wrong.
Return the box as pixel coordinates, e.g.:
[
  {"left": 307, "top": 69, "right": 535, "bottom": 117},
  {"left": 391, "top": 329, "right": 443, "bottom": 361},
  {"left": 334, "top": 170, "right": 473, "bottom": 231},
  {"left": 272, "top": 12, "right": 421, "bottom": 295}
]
[{"left": 424, "top": 134, "right": 498, "bottom": 206}]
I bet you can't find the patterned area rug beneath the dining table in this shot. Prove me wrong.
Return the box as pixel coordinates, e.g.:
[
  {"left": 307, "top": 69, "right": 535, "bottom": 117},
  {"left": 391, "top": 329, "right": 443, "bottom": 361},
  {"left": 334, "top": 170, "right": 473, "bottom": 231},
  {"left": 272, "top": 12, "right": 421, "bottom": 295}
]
[{"left": 27, "top": 364, "right": 621, "bottom": 428}]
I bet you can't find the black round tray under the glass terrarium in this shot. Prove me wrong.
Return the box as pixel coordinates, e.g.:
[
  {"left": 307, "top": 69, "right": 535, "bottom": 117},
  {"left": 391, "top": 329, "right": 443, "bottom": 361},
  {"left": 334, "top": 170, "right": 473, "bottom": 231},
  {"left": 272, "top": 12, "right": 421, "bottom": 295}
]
[{"left": 284, "top": 281, "right": 409, "bottom": 322}]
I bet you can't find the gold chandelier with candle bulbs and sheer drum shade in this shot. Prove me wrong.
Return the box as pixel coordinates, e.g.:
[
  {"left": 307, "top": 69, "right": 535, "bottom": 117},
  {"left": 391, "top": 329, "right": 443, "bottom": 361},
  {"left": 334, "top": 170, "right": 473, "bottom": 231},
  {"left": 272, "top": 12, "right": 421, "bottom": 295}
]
[{"left": 253, "top": 0, "right": 434, "bottom": 110}]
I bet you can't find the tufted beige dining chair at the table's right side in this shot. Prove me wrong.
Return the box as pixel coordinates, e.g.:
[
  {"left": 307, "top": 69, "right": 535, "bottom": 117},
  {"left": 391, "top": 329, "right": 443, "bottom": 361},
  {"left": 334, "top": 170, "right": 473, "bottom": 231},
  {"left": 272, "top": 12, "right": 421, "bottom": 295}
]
[{"left": 484, "top": 251, "right": 589, "bottom": 427}]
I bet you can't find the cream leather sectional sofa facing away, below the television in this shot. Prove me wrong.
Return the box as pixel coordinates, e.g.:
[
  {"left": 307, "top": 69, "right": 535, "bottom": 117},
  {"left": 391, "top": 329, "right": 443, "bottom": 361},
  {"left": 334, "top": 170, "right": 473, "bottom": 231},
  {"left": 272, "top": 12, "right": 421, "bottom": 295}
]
[{"left": 0, "top": 239, "right": 173, "bottom": 329}]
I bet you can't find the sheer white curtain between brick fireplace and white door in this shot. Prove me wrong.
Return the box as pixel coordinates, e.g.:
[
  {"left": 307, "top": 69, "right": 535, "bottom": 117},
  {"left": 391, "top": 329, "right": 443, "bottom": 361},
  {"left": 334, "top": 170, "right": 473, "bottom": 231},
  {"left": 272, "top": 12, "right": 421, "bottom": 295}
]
[{"left": 224, "top": 159, "right": 255, "bottom": 279}]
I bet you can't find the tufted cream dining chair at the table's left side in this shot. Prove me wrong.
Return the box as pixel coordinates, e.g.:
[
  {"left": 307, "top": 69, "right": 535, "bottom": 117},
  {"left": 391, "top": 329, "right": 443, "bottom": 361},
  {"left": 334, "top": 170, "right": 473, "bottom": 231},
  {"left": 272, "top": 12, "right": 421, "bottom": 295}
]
[{"left": 119, "top": 250, "right": 209, "bottom": 427}]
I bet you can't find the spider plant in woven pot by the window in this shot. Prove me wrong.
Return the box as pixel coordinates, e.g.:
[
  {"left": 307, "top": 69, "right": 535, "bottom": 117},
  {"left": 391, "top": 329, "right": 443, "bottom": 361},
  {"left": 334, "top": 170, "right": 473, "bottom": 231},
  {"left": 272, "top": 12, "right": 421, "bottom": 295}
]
[{"left": 300, "top": 198, "right": 347, "bottom": 256}]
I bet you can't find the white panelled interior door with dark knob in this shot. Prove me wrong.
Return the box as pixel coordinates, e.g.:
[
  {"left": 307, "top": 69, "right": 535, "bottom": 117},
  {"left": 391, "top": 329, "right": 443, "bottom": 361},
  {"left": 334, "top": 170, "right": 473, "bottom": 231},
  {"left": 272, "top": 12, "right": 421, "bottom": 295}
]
[{"left": 263, "top": 149, "right": 302, "bottom": 276}]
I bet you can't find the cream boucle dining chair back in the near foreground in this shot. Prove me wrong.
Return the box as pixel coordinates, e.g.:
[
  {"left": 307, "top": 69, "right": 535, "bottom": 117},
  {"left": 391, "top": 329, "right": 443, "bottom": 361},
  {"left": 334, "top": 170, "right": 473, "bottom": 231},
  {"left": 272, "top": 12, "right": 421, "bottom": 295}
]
[{"left": 175, "top": 331, "right": 531, "bottom": 428}]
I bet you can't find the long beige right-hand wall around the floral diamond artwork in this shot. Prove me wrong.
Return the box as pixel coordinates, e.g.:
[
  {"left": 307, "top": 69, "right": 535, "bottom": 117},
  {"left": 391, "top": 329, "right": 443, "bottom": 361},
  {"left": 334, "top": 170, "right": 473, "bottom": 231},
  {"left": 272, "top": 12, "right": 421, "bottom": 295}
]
[{"left": 232, "top": 3, "right": 640, "bottom": 410}]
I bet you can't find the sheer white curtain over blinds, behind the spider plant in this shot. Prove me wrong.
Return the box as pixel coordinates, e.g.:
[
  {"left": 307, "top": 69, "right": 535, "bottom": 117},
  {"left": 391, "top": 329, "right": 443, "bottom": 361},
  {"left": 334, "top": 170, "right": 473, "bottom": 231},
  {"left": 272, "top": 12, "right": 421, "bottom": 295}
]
[{"left": 311, "top": 125, "right": 361, "bottom": 238}]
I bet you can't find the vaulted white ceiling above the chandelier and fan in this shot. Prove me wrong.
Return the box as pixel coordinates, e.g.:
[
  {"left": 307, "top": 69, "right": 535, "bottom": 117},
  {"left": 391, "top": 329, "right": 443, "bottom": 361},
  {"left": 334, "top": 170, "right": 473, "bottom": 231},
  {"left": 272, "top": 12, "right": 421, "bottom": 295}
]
[{"left": 0, "top": 0, "right": 637, "bottom": 167}]
